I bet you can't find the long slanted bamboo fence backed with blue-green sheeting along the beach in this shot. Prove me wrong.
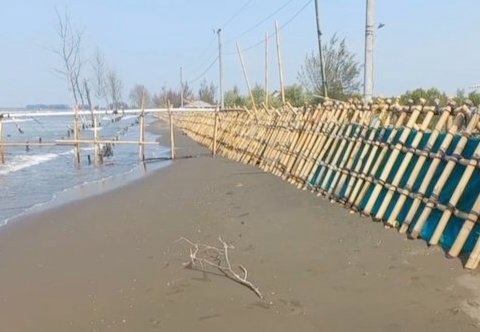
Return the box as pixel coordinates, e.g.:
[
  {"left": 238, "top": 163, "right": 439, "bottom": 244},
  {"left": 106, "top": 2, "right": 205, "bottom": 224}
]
[{"left": 160, "top": 100, "right": 480, "bottom": 269}]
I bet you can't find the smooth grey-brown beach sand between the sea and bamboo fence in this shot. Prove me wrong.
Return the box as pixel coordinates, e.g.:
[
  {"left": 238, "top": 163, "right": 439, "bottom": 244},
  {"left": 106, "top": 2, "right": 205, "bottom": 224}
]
[{"left": 0, "top": 122, "right": 480, "bottom": 332}]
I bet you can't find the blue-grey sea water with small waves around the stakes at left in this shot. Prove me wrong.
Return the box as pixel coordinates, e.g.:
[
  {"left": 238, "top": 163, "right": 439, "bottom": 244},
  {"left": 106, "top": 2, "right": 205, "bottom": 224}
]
[{"left": 0, "top": 109, "right": 169, "bottom": 225}]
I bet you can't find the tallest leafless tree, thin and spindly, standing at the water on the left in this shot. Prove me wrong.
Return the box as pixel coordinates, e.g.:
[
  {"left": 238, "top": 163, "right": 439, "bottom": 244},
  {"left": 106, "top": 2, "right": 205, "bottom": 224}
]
[{"left": 53, "top": 8, "right": 84, "bottom": 105}]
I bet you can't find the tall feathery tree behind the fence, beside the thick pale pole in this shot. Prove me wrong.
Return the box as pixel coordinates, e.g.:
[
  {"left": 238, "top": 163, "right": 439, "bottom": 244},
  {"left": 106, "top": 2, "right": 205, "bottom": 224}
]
[{"left": 298, "top": 35, "right": 360, "bottom": 99}]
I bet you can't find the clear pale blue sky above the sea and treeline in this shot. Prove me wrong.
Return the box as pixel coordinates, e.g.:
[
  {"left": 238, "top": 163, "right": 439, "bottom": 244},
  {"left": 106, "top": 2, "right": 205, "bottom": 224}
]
[{"left": 0, "top": 0, "right": 480, "bottom": 107}]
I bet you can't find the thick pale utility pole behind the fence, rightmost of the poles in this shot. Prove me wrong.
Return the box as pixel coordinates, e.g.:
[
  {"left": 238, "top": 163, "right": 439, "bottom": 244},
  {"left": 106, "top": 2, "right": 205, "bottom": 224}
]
[{"left": 363, "top": 0, "right": 375, "bottom": 103}]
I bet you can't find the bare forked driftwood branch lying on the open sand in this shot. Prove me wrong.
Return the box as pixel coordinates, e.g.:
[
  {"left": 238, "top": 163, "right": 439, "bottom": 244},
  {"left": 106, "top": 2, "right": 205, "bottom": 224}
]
[{"left": 174, "top": 236, "right": 263, "bottom": 299}]
